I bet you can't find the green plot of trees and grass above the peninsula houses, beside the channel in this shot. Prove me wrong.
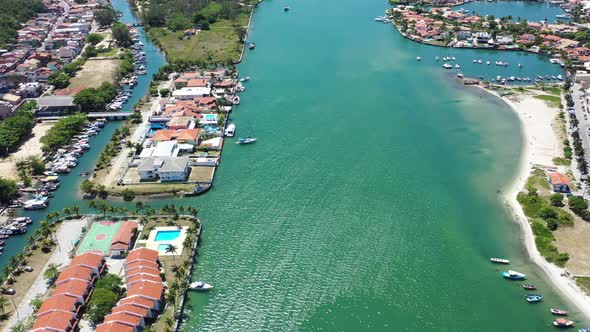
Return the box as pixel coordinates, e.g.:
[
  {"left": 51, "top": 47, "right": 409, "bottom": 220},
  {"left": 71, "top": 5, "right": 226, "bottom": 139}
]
[{"left": 130, "top": 0, "right": 262, "bottom": 67}]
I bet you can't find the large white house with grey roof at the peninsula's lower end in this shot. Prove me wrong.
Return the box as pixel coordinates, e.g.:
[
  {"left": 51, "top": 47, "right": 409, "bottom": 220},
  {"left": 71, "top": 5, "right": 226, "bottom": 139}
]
[{"left": 137, "top": 156, "right": 190, "bottom": 182}]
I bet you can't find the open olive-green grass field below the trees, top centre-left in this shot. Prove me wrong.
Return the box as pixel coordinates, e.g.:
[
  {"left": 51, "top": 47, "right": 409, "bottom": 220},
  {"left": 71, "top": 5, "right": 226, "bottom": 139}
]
[{"left": 150, "top": 14, "right": 249, "bottom": 62}]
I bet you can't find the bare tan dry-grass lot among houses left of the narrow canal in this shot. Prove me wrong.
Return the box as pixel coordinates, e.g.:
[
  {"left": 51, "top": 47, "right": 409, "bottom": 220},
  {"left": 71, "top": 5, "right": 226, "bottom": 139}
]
[{"left": 69, "top": 59, "right": 121, "bottom": 88}]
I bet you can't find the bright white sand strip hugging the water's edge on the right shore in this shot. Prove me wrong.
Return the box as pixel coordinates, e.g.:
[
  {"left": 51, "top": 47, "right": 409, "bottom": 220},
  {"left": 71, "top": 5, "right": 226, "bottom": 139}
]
[{"left": 480, "top": 87, "right": 590, "bottom": 319}]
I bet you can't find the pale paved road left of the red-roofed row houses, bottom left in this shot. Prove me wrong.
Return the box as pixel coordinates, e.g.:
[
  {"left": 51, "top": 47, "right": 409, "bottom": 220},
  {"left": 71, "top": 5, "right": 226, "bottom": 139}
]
[{"left": 4, "top": 217, "right": 87, "bottom": 331}]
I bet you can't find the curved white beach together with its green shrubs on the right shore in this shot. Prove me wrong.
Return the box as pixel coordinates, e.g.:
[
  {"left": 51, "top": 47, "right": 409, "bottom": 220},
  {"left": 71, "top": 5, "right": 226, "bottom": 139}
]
[{"left": 479, "top": 87, "right": 590, "bottom": 317}]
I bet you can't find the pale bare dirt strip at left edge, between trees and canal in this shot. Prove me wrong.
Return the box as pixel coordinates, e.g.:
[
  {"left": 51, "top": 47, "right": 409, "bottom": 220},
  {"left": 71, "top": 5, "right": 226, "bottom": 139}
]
[{"left": 0, "top": 122, "right": 54, "bottom": 180}]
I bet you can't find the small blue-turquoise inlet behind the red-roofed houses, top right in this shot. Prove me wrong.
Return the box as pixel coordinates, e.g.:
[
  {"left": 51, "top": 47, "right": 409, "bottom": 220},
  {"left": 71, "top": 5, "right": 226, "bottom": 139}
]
[{"left": 454, "top": 1, "right": 565, "bottom": 23}]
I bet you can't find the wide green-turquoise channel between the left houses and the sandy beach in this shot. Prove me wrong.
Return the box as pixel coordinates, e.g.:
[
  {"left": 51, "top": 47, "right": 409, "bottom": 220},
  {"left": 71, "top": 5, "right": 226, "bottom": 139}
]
[{"left": 6, "top": 0, "right": 580, "bottom": 331}]
